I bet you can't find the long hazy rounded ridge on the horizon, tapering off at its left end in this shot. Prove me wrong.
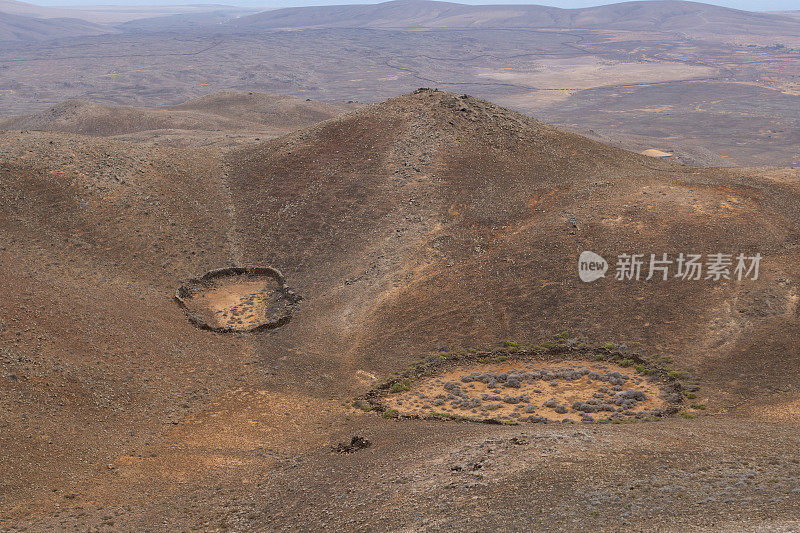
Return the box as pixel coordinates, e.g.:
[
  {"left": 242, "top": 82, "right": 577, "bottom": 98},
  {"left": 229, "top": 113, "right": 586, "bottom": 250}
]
[{"left": 230, "top": 0, "right": 800, "bottom": 35}]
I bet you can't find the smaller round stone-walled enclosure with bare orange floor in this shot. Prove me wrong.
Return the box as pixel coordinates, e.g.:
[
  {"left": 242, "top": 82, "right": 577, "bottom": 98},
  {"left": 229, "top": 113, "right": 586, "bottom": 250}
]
[{"left": 175, "top": 267, "right": 300, "bottom": 333}]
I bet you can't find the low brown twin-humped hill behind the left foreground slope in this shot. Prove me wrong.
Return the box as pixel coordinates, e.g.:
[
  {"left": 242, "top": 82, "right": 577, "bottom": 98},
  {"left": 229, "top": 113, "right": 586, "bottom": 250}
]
[{"left": 0, "top": 91, "right": 355, "bottom": 140}]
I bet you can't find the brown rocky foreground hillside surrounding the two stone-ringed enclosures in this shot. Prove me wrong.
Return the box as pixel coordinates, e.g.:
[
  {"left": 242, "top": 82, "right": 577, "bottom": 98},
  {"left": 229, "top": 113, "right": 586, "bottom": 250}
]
[{"left": 0, "top": 91, "right": 800, "bottom": 531}]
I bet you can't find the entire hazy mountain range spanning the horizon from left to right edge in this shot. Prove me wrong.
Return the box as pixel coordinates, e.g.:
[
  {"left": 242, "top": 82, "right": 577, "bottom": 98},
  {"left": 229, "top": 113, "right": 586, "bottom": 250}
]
[{"left": 0, "top": 0, "right": 800, "bottom": 41}]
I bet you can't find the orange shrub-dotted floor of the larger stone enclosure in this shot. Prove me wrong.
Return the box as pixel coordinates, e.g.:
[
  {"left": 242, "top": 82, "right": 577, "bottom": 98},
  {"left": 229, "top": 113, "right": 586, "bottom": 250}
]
[{"left": 366, "top": 353, "right": 683, "bottom": 424}]
